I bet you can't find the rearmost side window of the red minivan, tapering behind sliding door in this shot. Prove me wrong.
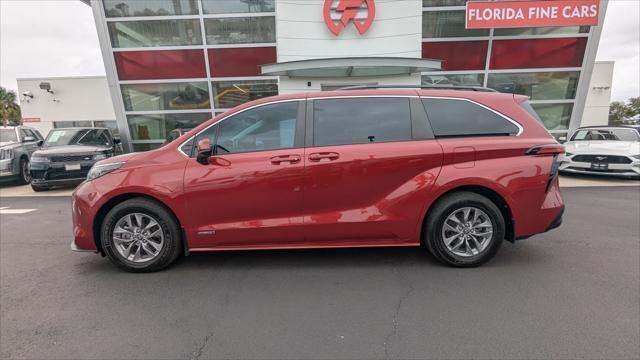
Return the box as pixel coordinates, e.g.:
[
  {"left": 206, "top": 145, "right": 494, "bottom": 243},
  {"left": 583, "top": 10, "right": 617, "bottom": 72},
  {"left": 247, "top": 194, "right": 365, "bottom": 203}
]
[{"left": 422, "top": 98, "right": 520, "bottom": 137}]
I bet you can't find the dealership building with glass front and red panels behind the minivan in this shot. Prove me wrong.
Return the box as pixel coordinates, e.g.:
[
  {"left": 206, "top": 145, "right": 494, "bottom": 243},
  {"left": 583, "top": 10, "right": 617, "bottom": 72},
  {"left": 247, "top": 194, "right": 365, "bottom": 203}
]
[{"left": 82, "top": 0, "right": 610, "bottom": 151}]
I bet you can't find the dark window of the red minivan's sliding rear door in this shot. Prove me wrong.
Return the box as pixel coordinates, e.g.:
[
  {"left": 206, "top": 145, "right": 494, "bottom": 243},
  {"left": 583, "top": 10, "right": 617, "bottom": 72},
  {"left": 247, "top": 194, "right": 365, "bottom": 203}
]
[{"left": 313, "top": 97, "right": 411, "bottom": 146}]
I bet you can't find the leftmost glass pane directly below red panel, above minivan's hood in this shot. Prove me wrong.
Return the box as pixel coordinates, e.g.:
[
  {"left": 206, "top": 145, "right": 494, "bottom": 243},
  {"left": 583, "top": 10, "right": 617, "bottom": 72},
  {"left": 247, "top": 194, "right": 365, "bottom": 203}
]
[{"left": 122, "top": 81, "right": 211, "bottom": 111}]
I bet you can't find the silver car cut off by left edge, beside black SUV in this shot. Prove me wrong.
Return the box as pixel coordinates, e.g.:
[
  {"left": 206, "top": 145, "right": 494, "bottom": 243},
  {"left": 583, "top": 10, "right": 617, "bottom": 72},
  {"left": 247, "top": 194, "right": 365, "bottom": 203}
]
[{"left": 0, "top": 126, "right": 44, "bottom": 184}]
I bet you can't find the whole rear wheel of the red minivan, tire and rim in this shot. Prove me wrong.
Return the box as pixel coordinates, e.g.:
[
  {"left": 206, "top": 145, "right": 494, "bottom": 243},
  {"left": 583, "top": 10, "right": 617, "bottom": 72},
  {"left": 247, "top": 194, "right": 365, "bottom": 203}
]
[{"left": 422, "top": 191, "right": 505, "bottom": 267}]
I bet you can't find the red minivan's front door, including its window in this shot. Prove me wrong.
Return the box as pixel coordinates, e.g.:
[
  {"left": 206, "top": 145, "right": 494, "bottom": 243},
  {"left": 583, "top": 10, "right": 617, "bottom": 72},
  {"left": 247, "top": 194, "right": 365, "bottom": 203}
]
[{"left": 184, "top": 101, "right": 305, "bottom": 249}]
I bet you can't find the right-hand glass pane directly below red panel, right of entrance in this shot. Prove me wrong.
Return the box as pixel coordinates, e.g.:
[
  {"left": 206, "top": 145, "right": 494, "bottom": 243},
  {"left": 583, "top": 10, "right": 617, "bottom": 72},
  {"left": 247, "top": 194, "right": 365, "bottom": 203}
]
[{"left": 487, "top": 71, "right": 580, "bottom": 100}]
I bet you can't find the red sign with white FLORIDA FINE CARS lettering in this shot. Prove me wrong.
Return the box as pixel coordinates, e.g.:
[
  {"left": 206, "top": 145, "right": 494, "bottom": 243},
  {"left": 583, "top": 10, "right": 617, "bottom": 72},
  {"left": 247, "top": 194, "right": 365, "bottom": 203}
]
[{"left": 466, "top": 0, "right": 600, "bottom": 29}]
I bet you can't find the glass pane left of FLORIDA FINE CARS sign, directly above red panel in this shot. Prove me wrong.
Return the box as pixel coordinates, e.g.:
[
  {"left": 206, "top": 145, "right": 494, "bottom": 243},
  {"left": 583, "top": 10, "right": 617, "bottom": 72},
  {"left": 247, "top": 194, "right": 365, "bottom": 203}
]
[{"left": 422, "top": 10, "right": 489, "bottom": 38}]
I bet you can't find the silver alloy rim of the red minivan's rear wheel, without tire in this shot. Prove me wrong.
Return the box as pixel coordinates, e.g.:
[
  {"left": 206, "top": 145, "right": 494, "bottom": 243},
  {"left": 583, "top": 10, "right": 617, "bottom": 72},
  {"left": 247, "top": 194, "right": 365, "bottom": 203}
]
[{"left": 442, "top": 207, "right": 493, "bottom": 257}]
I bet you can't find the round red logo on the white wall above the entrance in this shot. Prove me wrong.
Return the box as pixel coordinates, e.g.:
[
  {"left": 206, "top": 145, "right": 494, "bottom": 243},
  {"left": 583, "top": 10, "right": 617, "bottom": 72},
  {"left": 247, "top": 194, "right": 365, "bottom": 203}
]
[{"left": 324, "top": 0, "right": 376, "bottom": 35}]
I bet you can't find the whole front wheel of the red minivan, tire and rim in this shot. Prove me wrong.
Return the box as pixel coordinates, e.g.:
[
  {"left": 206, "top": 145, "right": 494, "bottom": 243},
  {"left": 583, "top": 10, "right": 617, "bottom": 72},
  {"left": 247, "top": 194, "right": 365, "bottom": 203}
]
[{"left": 100, "top": 198, "right": 182, "bottom": 272}]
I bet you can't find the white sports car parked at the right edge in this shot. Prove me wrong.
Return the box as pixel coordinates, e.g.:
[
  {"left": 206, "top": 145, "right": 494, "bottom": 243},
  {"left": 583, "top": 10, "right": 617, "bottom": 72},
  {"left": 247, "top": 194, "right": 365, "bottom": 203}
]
[{"left": 560, "top": 126, "right": 640, "bottom": 178}]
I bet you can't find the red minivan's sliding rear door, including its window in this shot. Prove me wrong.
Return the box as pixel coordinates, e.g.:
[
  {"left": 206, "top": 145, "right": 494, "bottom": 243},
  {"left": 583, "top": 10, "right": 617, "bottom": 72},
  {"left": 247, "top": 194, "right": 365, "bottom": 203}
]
[{"left": 304, "top": 97, "right": 442, "bottom": 246}]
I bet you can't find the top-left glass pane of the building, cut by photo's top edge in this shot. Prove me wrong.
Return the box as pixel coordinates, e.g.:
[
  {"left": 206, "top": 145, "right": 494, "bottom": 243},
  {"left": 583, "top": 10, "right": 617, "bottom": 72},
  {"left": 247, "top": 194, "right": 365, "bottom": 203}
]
[{"left": 104, "top": 0, "right": 198, "bottom": 17}]
